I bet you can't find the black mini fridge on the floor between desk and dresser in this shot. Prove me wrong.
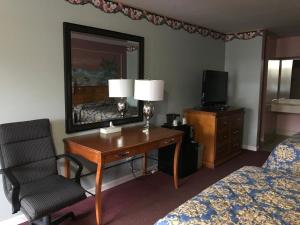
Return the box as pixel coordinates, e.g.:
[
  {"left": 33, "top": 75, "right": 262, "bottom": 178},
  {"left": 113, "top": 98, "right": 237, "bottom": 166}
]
[{"left": 158, "top": 125, "right": 198, "bottom": 178}]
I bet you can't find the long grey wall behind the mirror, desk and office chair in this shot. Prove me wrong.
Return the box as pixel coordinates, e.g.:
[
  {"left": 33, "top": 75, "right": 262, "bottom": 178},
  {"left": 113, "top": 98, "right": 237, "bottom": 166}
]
[{"left": 0, "top": 0, "right": 225, "bottom": 221}]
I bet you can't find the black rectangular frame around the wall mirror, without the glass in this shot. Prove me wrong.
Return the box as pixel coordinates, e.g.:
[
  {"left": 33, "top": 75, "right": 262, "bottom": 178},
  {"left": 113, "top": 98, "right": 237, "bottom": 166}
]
[{"left": 63, "top": 22, "right": 144, "bottom": 133}]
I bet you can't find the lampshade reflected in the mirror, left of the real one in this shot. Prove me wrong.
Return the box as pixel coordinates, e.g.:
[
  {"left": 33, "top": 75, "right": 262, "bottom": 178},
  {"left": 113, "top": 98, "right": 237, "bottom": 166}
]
[{"left": 108, "top": 79, "right": 133, "bottom": 98}]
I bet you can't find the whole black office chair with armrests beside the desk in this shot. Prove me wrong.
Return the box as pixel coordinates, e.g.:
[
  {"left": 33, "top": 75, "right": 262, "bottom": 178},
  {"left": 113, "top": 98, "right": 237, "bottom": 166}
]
[{"left": 0, "top": 119, "right": 86, "bottom": 225}]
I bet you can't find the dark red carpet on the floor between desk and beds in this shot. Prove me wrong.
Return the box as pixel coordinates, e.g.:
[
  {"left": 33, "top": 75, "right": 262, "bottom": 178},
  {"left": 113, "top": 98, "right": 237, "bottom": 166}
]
[{"left": 21, "top": 151, "right": 270, "bottom": 225}]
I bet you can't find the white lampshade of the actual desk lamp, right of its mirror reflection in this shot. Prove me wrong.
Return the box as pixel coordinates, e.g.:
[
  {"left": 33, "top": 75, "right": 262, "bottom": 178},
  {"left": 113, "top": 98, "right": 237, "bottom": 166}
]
[{"left": 134, "top": 80, "right": 164, "bottom": 101}]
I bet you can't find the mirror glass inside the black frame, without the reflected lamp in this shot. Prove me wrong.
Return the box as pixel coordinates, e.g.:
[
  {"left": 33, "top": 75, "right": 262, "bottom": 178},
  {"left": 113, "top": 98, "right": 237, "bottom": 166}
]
[{"left": 71, "top": 32, "right": 139, "bottom": 125}]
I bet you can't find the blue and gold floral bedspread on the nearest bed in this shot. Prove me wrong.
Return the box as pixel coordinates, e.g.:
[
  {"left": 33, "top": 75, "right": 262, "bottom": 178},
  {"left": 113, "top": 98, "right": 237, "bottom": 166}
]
[{"left": 155, "top": 166, "right": 300, "bottom": 225}]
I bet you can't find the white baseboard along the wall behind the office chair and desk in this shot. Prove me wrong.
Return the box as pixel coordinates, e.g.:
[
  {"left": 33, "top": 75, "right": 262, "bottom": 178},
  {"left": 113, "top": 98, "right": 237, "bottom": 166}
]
[{"left": 0, "top": 165, "right": 157, "bottom": 225}]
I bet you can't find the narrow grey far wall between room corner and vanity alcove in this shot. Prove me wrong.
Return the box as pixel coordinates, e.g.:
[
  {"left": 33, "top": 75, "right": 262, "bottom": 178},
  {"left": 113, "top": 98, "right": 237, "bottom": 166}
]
[{"left": 225, "top": 37, "right": 263, "bottom": 150}]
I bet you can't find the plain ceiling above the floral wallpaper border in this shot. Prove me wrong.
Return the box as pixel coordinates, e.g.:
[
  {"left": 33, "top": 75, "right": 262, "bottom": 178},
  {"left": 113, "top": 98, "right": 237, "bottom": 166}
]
[{"left": 115, "top": 0, "right": 300, "bottom": 35}]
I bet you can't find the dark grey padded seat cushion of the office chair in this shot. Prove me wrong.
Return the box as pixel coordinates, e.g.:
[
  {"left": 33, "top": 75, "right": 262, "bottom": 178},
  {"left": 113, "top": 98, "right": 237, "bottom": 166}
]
[{"left": 20, "top": 175, "right": 86, "bottom": 220}]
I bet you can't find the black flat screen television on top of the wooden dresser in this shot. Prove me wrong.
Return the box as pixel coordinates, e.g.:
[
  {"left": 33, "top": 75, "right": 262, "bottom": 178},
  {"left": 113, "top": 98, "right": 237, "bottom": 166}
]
[{"left": 201, "top": 70, "right": 228, "bottom": 106}]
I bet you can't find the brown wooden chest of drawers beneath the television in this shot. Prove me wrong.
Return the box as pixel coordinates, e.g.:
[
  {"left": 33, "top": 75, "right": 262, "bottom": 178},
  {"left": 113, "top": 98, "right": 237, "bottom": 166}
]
[{"left": 185, "top": 108, "right": 244, "bottom": 168}]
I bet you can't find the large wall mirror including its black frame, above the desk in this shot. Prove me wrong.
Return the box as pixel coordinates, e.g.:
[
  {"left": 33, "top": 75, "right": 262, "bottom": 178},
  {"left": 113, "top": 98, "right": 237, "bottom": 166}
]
[{"left": 64, "top": 23, "right": 144, "bottom": 133}]
